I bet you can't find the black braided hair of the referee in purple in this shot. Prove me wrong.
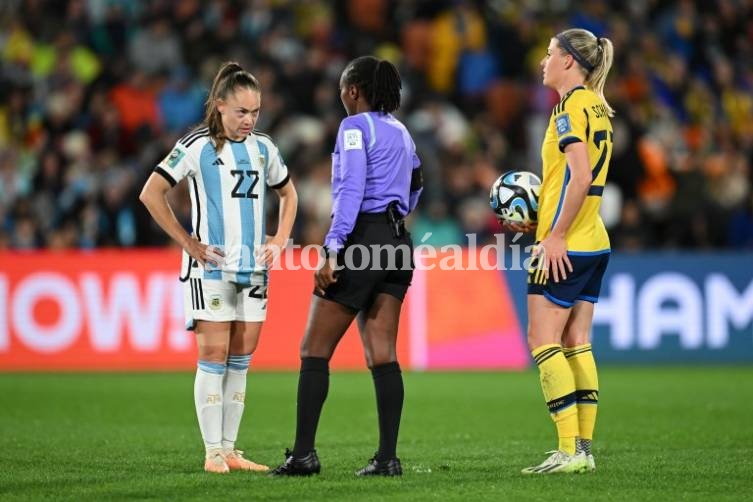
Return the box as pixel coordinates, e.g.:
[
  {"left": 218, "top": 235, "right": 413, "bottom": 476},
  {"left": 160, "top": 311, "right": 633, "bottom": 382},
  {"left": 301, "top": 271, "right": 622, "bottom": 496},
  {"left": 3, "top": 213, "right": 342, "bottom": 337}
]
[{"left": 343, "top": 56, "right": 403, "bottom": 113}]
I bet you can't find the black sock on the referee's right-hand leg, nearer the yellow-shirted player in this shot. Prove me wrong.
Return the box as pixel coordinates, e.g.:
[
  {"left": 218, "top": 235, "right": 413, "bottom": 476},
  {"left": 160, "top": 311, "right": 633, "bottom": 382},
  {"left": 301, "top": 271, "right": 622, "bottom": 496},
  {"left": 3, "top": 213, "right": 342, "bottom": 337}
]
[{"left": 371, "top": 362, "right": 404, "bottom": 460}]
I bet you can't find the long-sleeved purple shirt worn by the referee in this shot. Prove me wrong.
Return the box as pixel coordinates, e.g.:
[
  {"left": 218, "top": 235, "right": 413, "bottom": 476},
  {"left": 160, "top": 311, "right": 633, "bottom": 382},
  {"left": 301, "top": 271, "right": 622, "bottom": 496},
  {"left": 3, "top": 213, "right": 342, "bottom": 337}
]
[{"left": 324, "top": 112, "right": 421, "bottom": 251}]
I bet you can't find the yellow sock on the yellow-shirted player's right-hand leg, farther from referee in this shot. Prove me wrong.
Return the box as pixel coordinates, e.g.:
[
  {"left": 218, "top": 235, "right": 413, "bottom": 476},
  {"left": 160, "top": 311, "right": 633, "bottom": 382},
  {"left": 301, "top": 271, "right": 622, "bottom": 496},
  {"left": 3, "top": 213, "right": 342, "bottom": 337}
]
[{"left": 564, "top": 343, "right": 599, "bottom": 440}]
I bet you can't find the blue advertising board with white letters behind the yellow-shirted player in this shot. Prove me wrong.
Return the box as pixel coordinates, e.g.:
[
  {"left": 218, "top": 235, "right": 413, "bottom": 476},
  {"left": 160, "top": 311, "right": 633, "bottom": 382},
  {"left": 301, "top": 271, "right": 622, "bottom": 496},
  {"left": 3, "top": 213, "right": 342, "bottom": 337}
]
[{"left": 504, "top": 253, "right": 753, "bottom": 363}]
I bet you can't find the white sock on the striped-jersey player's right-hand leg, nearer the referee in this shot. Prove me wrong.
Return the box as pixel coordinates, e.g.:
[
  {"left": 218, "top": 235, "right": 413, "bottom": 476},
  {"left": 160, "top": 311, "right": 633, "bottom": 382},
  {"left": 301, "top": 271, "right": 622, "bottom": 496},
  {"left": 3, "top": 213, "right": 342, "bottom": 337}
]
[{"left": 222, "top": 354, "right": 251, "bottom": 453}]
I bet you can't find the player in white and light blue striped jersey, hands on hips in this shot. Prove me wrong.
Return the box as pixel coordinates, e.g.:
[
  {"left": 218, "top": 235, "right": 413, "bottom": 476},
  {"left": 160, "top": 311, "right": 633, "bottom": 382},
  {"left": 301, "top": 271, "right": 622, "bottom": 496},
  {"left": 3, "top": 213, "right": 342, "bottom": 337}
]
[{"left": 140, "top": 62, "right": 298, "bottom": 473}]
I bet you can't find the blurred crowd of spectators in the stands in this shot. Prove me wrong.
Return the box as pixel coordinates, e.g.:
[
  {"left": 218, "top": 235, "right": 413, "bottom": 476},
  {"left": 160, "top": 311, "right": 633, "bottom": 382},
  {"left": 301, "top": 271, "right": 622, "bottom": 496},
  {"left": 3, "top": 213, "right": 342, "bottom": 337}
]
[{"left": 0, "top": 0, "right": 753, "bottom": 250}]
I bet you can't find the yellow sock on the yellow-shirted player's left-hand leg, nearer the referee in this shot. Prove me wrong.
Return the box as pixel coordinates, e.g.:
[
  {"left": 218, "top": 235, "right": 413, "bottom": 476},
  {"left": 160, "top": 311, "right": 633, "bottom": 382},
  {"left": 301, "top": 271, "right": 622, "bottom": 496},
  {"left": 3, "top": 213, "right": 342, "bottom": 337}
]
[{"left": 531, "top": 344, "right": 578, "bottom": 455}]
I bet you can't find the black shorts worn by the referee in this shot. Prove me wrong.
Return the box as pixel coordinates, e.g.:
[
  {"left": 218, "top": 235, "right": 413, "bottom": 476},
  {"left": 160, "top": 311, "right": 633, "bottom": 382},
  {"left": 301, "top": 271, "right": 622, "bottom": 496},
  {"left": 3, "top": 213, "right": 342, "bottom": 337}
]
[{"left": 314, "top": 213, "right": 414, "bottom": 311}]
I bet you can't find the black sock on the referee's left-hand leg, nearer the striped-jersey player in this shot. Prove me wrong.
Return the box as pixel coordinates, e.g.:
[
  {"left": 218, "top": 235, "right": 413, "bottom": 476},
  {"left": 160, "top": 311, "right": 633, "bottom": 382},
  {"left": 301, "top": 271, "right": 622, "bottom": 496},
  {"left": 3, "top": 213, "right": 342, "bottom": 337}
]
[{"left": 293, "top": 357, "right": 329, "bottom": 457}]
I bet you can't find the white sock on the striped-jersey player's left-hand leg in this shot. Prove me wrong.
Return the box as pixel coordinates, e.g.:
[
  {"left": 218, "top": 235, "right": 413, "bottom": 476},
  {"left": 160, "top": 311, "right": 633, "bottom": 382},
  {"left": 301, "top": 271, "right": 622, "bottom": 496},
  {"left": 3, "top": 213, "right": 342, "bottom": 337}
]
[{"left": 193, "top": 361, "right": 225, "bottom": 453}]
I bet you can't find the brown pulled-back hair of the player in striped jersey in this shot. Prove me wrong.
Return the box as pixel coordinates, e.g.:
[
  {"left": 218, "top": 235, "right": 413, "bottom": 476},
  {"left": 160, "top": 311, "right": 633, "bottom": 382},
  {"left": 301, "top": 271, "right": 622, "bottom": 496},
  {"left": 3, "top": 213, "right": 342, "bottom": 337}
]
[{"left": 204, "top": 61, "right": 261, "bottom": 152}]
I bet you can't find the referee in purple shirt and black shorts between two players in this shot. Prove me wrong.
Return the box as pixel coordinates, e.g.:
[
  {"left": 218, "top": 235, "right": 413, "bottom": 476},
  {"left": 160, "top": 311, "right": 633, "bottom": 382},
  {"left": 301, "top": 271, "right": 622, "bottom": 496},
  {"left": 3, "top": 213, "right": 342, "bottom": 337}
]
[{"left": 271, "top": 56, "right": 422, "bottom": 476}]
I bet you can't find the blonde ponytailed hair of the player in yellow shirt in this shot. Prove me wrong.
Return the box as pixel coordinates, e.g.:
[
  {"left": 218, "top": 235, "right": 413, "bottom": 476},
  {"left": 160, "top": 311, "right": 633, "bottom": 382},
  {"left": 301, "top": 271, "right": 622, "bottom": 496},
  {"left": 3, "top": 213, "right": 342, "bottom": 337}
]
[{"left": 555, "top": 28, "right": 614, "bottom": 117}]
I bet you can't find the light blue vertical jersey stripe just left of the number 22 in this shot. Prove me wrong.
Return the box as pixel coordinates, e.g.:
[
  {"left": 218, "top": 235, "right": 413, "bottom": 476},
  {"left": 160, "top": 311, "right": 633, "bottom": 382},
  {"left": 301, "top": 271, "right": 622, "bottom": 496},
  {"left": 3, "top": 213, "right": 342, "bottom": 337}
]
[{"left": 199, "top": 142, "right": 225, "bottom": 279}]
